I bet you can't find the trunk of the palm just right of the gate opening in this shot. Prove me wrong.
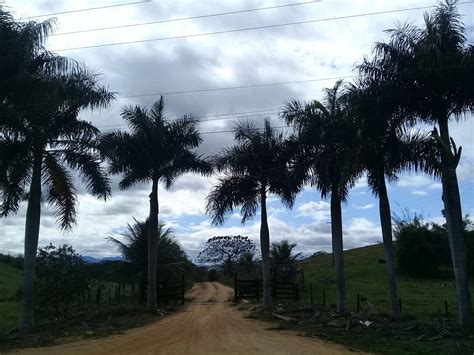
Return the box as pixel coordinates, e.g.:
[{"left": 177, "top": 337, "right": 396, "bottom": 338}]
[{"left": 260, "top": 188, "right": 272, "bottom": 310}]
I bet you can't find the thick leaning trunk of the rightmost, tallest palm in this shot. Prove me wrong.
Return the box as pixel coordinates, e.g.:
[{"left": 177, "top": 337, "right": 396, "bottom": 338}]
[{"left": 438, "top": 117, "right": 471, "bottom": 326}]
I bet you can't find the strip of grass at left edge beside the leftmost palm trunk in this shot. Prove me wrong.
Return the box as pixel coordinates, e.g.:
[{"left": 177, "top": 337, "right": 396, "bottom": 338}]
[{"left": 0, "top": 263, "right": 22, "bottom": 333}]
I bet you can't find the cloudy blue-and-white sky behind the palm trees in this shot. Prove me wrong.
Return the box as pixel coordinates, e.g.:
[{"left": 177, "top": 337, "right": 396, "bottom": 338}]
[{"left": 0, "top": 0, "right": 474, "bottom": 259}]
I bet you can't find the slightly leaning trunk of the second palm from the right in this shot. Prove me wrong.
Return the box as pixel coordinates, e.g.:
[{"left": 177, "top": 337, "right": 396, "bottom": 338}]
[{"left": 379, "top": 177, "right": 401, "bottom": 320}]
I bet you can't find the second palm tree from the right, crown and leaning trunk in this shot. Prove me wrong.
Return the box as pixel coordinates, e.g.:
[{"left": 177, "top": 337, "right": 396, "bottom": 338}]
[{"left": 349, "top": 80, "right": 436, "bottom": 320}]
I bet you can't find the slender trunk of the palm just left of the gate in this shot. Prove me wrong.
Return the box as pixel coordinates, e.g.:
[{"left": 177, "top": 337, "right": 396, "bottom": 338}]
[{"left": 146, "top": 179, "right": 159, "bottom": 312}]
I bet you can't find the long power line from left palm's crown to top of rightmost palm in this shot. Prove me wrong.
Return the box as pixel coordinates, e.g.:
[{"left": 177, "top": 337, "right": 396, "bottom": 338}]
[{"left": 52, "top": 1, "right": 474, "bottom": 52}]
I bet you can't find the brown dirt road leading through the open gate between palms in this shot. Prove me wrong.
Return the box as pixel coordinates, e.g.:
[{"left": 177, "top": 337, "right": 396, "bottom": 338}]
[{"left": 22, "top": 282, "right": 360, "bottom": 355}]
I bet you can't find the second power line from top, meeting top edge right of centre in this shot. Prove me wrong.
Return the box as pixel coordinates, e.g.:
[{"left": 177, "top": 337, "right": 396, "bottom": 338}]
[{"left": 51, "top": 0, "right": 322, "bottom": 36}]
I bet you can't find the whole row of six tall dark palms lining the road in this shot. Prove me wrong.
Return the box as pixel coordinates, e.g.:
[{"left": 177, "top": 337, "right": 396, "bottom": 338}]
[{"left": 0, "top": 2, "right": 474, "bottom": 331}]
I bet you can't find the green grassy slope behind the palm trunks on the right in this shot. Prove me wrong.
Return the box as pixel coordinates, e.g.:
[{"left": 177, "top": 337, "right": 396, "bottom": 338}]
[{"left": 301, "top": 244, "right": 474, "bottom": 319}]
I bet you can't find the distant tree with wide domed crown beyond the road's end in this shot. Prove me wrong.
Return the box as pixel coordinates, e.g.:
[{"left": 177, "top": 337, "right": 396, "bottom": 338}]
[{"left": 196, "top": 235, "right": 255, "bottom": 274}]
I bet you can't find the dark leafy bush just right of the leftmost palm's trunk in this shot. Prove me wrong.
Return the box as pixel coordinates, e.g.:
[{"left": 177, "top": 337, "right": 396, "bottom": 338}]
[{"left": 34, "top": 244, "right": 89, "bottom": 321}]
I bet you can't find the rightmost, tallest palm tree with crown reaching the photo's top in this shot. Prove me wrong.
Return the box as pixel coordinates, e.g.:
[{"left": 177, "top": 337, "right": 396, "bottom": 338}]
[{"left": 362, "top": 0, "right": 474, "bottom": 325}]
